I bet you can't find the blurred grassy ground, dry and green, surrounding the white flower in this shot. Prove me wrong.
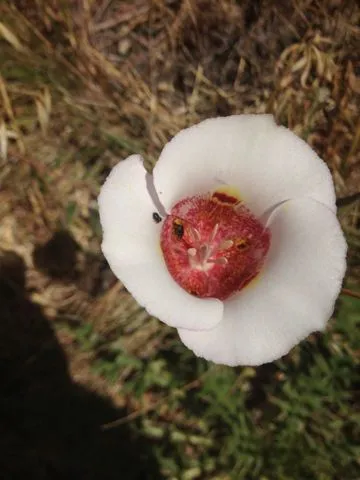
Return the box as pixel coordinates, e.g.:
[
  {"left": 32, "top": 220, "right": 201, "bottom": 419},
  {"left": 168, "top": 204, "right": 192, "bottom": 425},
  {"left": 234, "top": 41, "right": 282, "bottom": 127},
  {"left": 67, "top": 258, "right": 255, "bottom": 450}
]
[{"left": 0, "top": 0, "right": 360, "bottom": 480}]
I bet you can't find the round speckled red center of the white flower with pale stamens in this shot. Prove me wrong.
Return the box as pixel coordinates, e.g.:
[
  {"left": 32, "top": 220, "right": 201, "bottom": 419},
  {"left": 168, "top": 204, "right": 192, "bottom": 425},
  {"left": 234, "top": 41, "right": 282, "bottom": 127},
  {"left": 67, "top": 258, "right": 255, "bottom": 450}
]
[{"left": 161, "top": 190, "right": 270, "bottom": 300}]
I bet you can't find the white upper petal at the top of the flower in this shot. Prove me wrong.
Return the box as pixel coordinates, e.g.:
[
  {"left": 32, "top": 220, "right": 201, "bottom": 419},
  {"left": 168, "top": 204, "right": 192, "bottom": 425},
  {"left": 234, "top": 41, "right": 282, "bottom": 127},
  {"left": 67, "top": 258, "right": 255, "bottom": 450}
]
[{"left": 154, "top": 115, "right": 335, "bottom": 215}]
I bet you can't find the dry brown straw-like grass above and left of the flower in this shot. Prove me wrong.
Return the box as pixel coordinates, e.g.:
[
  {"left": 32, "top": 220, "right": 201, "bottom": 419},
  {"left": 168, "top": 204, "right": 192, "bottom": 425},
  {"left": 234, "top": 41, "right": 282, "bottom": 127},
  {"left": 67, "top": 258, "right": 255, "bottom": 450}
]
[{"left": 0, "top": 0, "right": 360, "bottom": 476}]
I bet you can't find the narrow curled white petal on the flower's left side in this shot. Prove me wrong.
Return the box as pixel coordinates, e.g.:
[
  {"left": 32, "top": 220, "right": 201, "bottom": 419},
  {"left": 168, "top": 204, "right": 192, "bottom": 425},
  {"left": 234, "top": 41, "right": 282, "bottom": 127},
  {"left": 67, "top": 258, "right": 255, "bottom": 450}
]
[{"left": 99, "top": 155, "right": 223, "bottom": 330}]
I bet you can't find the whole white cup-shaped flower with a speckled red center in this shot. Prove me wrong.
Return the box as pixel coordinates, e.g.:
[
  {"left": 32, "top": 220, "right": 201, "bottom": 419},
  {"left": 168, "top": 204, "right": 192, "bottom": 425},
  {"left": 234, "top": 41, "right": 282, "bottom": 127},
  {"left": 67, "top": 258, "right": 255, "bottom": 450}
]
[{"left": 99, "top": 115, "right": 346, "bottom": 366}]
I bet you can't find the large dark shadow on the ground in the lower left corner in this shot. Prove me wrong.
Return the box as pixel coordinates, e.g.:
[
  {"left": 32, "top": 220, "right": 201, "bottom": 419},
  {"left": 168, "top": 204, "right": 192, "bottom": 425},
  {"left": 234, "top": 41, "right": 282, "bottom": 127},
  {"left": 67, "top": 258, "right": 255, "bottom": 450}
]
[{"left": 0, "top": 252, "right": 162, "bottom": 480}]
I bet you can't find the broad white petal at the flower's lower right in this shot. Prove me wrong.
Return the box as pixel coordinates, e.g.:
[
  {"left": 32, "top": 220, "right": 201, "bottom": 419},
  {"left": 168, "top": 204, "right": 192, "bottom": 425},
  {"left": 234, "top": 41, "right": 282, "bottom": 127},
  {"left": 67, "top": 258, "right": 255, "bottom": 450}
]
[{"left": 179, "top": 199, "right": 346, "bottom": 365}]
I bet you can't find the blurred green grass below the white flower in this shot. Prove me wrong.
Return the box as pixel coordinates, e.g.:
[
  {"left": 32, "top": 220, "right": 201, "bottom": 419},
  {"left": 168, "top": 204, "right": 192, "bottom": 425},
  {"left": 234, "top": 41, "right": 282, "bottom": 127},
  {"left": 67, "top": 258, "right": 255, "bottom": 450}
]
[{"left": 66, "top": 298, "right": 360, "bottom": 480}]
